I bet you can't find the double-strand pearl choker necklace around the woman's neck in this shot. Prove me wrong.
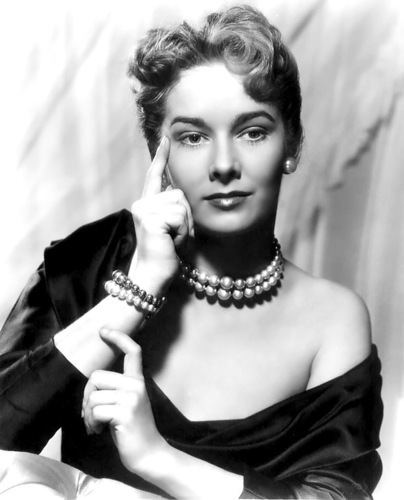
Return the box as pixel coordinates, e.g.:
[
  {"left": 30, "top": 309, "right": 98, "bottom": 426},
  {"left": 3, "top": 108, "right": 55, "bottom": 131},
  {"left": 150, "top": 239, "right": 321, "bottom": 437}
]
[{"left": 180, "top": 238, "right": 284, "bottom": 301}]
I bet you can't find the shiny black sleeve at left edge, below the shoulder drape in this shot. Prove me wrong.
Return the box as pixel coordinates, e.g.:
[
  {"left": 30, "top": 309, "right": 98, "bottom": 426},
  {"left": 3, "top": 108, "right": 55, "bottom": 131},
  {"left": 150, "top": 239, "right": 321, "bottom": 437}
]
[{"left": 0, "top": 266, "right": 85, "bottom": 453}]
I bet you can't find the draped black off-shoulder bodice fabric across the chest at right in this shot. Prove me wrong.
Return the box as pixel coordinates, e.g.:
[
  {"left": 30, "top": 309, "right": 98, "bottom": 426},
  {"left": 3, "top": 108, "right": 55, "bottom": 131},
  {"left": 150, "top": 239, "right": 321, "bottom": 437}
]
[{"left": 146, "top": 354, "right": 382, "bottom": 498}]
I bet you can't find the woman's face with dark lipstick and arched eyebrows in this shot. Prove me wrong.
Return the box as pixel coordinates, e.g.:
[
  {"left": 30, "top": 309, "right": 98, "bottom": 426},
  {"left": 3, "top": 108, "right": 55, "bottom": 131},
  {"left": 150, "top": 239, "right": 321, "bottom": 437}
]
[{"left": 161, "top": 63, "right": 285, "bottom": 234}]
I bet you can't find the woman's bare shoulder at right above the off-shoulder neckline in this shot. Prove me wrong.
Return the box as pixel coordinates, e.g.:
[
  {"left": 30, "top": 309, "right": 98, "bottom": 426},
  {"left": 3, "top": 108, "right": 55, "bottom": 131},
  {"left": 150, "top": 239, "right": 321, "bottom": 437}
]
[{"left": 289, "top": 264, "right": 371, "bottom": 388}]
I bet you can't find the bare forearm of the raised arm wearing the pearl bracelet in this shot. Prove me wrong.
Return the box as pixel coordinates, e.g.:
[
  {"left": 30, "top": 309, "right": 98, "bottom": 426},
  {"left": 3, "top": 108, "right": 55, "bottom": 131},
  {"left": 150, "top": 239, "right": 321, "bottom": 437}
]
[{"left": 54, "top": 269, "right": 165, "bottom": 377}]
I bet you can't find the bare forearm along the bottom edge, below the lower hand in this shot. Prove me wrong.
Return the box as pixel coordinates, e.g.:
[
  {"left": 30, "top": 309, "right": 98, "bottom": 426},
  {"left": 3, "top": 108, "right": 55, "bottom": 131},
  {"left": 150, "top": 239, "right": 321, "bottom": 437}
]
[{"left": 133, "top": 443, "right": 244, "bottom": 499}]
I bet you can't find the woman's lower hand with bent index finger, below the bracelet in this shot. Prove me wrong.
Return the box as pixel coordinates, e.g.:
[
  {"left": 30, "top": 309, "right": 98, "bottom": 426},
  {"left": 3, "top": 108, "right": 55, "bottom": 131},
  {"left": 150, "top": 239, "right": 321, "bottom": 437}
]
[{"left": 82, "top": 329, "right": 167, "bottom": 472}]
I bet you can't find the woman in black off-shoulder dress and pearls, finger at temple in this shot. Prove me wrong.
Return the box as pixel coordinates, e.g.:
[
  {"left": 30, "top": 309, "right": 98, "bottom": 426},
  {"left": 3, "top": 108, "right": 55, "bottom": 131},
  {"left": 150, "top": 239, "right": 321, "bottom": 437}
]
[{"left": 0, "top": 7, "right": 381, "bottom": 498}]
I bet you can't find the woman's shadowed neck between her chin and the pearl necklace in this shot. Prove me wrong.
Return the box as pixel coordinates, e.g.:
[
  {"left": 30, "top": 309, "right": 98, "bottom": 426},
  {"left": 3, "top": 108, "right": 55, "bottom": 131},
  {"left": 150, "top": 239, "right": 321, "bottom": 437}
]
[{"left": 184, "top": 225, "right": 274, "bottom": 278}]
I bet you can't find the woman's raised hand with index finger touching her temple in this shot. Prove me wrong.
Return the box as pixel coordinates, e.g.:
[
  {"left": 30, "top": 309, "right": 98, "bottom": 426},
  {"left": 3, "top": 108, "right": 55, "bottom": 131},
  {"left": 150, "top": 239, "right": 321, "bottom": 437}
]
[{"left": 129, "top": 137, "right": 193, "bottom": 290}]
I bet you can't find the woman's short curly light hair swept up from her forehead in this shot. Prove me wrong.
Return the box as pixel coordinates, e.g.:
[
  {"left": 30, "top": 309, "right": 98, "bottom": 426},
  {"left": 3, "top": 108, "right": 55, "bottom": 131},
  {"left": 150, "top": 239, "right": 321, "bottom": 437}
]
[{"left": 128, "top": 5, "right": 303, "bottom": 158}]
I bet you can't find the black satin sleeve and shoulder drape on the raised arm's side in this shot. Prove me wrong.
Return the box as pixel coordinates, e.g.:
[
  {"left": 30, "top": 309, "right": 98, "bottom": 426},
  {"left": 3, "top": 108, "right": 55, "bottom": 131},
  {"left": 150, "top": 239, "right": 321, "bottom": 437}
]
[{"left": 0, "top": 210, "right": 135, "bottom": 452}]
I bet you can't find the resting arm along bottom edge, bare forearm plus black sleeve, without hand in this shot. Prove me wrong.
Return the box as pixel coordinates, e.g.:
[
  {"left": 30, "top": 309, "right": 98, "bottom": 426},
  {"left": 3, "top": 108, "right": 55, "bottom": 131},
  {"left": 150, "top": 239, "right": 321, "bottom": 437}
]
[{"left": 129, "top": 443, "right": 380, "bottom": 500}]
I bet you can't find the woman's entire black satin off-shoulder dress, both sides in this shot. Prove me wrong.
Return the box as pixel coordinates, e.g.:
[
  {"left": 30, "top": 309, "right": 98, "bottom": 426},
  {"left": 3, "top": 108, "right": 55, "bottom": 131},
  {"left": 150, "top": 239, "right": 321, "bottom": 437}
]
[{"left": 0, "top": 210, "right": 382, "bottom": 499}]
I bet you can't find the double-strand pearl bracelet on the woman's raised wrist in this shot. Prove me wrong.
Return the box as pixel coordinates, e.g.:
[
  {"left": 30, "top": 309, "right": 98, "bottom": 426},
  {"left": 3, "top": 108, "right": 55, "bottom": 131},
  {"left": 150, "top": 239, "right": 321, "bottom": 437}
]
[{"left": 104, "top": 270, "right": 166, "bottom": 319}]
